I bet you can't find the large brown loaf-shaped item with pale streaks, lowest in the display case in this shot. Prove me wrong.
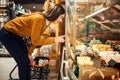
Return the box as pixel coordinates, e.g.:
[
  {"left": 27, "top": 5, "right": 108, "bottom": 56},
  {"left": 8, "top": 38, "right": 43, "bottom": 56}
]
[{"left": 78, "top": 66, "right": 120, "bottom": 80}]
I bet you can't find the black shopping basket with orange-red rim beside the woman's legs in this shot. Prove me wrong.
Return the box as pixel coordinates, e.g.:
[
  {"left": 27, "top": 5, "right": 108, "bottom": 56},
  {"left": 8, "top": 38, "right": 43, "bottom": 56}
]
[{"left": 9, "top": 56, "right": 50, "bottom": 80}]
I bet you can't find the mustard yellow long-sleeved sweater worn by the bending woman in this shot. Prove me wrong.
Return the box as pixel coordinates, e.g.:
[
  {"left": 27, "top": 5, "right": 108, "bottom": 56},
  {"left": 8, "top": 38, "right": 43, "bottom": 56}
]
[{"left": 5, "top": 14, "right": 54, "bottom": 54}]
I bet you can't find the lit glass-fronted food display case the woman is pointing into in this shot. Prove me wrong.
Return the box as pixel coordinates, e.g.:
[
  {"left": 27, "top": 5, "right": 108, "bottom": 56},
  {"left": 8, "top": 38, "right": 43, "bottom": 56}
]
[{"left": 61, "top": 0, "right": 120, "bottom": 80}]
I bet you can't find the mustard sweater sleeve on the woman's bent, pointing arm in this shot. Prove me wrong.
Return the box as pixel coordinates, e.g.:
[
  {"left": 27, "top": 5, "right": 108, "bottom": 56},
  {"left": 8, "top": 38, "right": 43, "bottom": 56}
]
[{"left": 31, "top": 15, "right": 54, "bottom": 46}]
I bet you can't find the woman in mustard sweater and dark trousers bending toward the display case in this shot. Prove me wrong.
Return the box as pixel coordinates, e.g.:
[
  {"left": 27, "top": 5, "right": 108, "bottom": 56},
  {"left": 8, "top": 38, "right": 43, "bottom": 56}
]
[{"left": 0, "top": 4, "right": 65, "bottom": 80}]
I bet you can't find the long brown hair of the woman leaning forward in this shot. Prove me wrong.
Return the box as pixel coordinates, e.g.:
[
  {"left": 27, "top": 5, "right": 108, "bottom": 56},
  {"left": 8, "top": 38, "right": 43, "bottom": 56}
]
[{"left": 44, "top": 4, "right": 65, "bottom": 21}]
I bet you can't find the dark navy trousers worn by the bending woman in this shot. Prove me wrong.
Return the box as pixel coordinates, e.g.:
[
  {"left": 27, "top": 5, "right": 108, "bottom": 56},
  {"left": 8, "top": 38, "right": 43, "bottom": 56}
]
[{"left": 0, "top": 28, "right": 31, "bottom": 80}]
